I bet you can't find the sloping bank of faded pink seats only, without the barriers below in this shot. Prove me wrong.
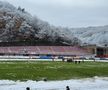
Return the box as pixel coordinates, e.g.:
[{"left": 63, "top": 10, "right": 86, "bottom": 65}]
[{"left": 0, "top": 46, "right": 90, "bottom": 55}]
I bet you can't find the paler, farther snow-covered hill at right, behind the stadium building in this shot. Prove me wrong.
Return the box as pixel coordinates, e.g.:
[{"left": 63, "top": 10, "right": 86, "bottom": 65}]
[{"left": 71, "top": 25, "right": 108, "bottom": 46}]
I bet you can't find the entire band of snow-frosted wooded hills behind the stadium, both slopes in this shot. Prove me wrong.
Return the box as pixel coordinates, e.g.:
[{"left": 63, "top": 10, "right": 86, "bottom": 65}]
[{"left": 0, "top": 1, "right": 108, "bottom": 46}]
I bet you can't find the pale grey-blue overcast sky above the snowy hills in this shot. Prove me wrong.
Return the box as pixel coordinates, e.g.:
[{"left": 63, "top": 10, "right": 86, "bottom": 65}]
[{"left": 2, "top": 0, "right": 108, "bottom": 27}]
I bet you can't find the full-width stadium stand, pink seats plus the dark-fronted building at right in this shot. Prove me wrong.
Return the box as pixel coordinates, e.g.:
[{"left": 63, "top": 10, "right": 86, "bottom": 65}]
[{"left": 0, "top": 42, "right": 108, "bottom": 59}]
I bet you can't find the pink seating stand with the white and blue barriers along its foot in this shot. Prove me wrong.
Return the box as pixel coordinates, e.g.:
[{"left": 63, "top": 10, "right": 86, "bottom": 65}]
[{"left": 0, "top": 46, "right": 92, "bottom": 59}]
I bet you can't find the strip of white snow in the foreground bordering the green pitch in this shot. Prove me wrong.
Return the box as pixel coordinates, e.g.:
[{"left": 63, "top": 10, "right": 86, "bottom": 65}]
[{"left": 0, "top": 77, "right": 108, "bottom": 90}]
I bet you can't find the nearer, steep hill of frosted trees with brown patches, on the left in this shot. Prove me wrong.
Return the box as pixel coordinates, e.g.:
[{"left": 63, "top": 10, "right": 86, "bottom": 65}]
[{"left": 0, "top": 1, "right": 81, "bottom": 45}]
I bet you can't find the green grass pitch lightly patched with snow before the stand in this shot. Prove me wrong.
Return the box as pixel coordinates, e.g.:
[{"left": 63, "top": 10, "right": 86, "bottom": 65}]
[{"left": 0, "top": 61, "right": 108, "bottom": 80}]
